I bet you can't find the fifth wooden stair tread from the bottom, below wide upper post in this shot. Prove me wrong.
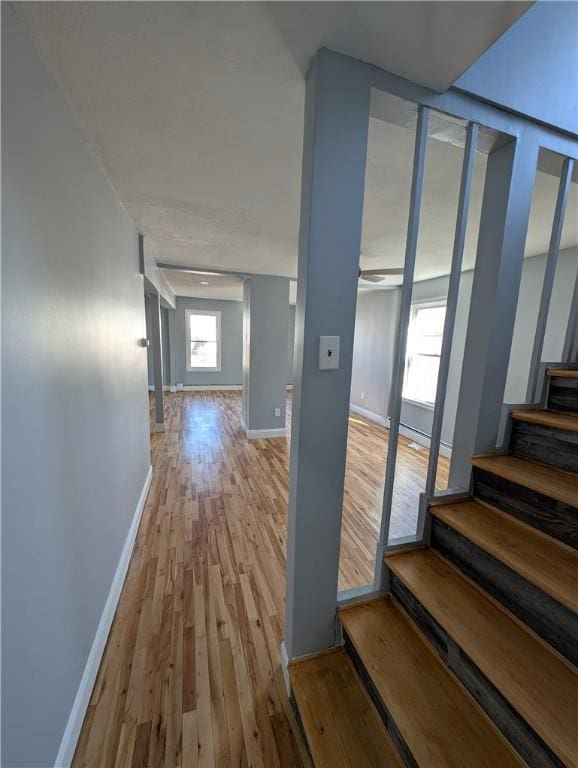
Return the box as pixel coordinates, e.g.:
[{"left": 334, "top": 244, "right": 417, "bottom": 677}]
[{"left": 472, "top": 454, "right": 578, "bottom": 507}]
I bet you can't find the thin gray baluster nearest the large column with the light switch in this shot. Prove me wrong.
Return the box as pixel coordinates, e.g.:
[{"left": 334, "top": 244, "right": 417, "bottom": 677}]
[{"left": 374, "top": 107, "right": 429, "bottom": 589}]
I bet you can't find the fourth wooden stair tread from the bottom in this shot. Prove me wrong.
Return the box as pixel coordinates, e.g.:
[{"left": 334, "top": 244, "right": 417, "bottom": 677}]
[{"left": 430, "top": 501, "right": 578, "bottom": 614}]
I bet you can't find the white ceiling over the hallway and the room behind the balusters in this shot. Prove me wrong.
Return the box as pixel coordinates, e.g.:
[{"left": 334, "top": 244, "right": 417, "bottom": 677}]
[{"left": 16, "top": 2, "right": 578, "bottom": 306}]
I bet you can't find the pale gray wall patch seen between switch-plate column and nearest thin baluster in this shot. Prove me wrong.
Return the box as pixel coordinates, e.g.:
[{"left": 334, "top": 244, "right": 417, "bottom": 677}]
[{"left": 350, "top": 290, "right": 399, "bottom": 417}]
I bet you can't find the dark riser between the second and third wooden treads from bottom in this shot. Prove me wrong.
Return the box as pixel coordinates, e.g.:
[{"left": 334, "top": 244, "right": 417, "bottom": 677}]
[{"left": 390, "top": 572, "right": 564, "bottom": 768}]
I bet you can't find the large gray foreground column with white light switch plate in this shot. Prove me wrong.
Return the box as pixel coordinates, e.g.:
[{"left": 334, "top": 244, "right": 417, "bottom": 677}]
[{"left": 285, "top": 49, "right": 369, "bottom": 658}]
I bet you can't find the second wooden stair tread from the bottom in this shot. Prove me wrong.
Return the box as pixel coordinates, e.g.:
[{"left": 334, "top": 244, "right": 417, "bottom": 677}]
[{"left": 339, "top": 598, "right": 524, "bottom": 768}]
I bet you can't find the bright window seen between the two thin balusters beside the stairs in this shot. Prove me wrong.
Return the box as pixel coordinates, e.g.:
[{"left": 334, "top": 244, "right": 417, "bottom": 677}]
[{"left": 403, "top": 301, "right": 446, "bottom": 406}]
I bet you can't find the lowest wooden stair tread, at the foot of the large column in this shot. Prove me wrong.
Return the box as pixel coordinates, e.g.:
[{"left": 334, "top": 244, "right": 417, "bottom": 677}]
[{"left": 289, "top": 650, "right": 403, "bottom": 768}]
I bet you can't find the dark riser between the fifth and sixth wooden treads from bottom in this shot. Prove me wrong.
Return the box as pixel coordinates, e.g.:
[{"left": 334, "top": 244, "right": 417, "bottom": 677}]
[{"left": 509, "top": 419, "right": 578, "bottom": 472}]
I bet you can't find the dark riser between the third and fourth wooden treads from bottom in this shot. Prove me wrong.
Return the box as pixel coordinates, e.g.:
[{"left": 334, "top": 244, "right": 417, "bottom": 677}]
[{"left": 431, "top": 517, "right": 578, "bottom": 665}]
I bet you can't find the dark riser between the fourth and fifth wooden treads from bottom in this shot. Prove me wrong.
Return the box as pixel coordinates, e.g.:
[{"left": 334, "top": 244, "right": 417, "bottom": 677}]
[{"left": 473, "top": 467, "right": 578, "bottom": 549}]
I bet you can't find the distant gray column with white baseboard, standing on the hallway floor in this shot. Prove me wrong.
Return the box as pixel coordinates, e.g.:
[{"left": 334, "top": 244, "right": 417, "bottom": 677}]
[{"left": 243, "top": 275, "right": 289, "bottom": 438}]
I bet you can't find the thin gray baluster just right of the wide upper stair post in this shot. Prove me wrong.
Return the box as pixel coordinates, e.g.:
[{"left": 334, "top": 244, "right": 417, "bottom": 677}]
[{"left": 526, "top": 157, "right": 574, "bottom": 396}]
